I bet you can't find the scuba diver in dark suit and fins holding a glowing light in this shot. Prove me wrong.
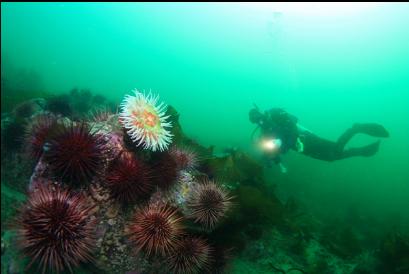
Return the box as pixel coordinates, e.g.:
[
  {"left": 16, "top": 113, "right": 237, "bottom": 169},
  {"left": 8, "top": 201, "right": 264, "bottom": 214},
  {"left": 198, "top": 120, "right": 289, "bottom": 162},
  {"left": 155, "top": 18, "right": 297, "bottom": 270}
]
[{"left": 249, "top": 106, "right": 389, "bottom": 173}]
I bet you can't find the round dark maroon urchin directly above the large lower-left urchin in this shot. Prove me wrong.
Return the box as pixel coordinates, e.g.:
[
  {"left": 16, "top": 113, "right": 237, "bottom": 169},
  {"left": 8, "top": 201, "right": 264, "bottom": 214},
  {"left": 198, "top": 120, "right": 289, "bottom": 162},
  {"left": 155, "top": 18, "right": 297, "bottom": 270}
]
[{"left": 44, "top": 122, "right": 105, "bottom": 185}]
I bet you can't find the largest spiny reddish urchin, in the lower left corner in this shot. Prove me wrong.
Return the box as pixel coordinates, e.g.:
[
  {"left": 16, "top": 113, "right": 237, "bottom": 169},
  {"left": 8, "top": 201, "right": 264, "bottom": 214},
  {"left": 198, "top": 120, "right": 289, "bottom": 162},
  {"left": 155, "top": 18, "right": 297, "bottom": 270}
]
[{"left": 17, "top": 185, "right": 96, "bottom": 273}]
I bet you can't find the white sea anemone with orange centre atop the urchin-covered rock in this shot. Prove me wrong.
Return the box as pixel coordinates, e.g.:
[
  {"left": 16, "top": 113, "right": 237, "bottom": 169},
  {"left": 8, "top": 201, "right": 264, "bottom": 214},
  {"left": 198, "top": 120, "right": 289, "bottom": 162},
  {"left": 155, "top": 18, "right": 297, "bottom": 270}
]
[{"left": 119, "top": 89, "right": 172, "bottom": 151}]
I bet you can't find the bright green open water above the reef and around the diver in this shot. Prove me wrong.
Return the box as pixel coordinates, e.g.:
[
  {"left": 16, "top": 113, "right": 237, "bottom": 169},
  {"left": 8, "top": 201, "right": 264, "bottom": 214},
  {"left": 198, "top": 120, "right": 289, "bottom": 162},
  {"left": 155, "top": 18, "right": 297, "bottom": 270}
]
[{"left": 1, "top": 3, "right": 409, "bottom": 274}]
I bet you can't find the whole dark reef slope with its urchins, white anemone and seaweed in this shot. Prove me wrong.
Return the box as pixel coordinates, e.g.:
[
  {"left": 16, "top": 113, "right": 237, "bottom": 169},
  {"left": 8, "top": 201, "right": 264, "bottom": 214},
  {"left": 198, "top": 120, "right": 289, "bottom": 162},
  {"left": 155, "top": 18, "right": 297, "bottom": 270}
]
[{"left": 1, "top": 89, "right": 409, "bottom": 274}]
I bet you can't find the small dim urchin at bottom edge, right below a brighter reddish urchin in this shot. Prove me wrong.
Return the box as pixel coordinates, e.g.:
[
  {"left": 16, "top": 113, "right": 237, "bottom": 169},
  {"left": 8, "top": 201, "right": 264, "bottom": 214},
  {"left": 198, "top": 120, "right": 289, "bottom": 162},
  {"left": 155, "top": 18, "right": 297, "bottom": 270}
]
[{"left": 168, "top": 237, "right": 210, "bottom": 274}]
